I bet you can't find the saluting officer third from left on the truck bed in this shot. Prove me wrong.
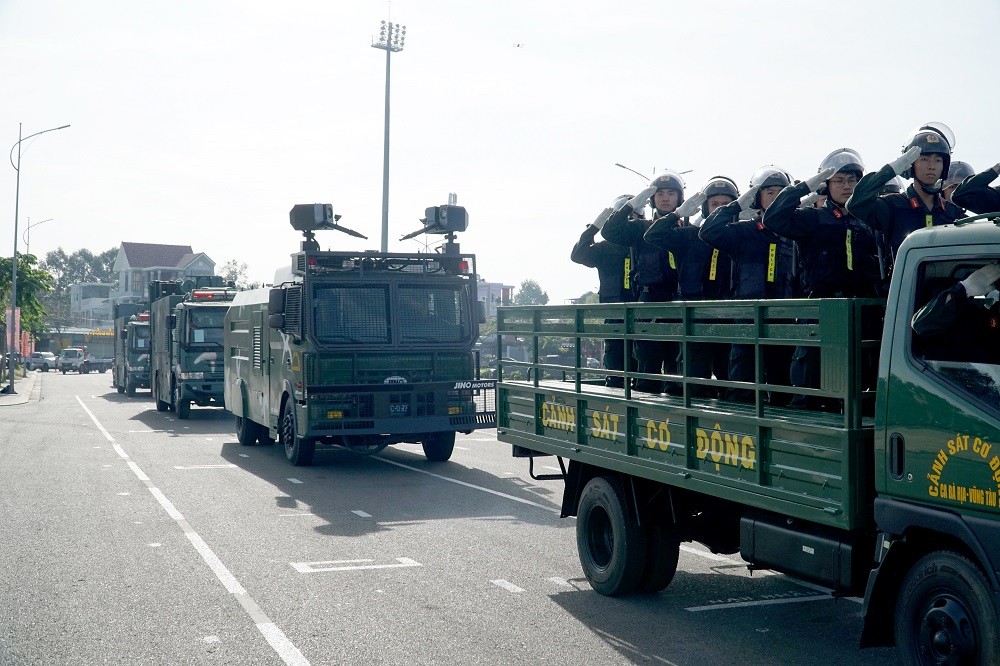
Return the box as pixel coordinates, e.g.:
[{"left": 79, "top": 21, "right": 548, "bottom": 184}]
[{"left": 645, "top": 176, "right": 740, "bottom": 397}]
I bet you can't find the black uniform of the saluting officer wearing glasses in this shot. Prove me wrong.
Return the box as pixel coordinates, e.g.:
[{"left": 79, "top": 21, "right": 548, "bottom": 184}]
[{"left": 764, "top": 183, "right": 880, "bottom": 407}]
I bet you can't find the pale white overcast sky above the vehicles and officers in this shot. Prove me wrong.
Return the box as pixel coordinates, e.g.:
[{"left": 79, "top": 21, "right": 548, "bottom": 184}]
[{"left": 0, "top": 0, "right": 1000, "bottom": 303}]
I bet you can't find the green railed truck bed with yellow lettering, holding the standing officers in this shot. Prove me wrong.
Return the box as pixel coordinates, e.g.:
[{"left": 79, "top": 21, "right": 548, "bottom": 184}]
[{"left": 498, "top": 299, "right": 881, "bottom": 529}]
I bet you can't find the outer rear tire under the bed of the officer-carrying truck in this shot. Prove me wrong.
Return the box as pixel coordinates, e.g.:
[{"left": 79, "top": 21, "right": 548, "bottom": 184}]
[{"left": 576, "top": 476, "right": 646, "bottom": 597}]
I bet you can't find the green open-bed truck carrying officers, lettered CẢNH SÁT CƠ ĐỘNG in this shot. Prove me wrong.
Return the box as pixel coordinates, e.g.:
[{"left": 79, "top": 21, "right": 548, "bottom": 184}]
[{"left": 497, "top": 218, "right": 1000, "bottom": 664}]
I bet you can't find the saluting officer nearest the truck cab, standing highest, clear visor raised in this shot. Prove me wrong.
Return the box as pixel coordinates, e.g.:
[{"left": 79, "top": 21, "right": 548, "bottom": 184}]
[{"left": 847, "top": 123, "right": 964, "bottom": 268}]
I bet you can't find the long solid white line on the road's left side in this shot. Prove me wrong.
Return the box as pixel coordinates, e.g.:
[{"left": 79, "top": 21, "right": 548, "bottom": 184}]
[{"left": 75, "top": 396, "right": 309, "bottom": 666}]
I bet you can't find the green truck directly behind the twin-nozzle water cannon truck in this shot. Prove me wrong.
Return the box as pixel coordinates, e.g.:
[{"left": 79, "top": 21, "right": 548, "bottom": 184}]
[{"left": 149, "top": 276, "right": 237, "bottom": 419}]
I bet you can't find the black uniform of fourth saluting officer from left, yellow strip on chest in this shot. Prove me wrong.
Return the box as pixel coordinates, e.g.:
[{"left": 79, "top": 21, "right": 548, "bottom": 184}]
[{"left": 698, "top": 201, "right": 795, "bottom": 402}]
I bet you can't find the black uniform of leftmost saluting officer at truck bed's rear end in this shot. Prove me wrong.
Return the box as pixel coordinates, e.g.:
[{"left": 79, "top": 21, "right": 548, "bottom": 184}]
[{"left": 570, "top": 225, "right": 635, "bottom": 387}]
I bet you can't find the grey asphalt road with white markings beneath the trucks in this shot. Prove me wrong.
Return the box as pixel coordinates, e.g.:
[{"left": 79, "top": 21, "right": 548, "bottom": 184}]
[{"left": 0, "top": 373, "right": 895, "bottom": 666}]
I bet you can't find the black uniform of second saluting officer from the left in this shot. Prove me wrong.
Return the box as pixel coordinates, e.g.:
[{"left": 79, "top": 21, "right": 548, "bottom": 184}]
[{"left": 601, "top": 205, "right": 677, "bottom": 393}]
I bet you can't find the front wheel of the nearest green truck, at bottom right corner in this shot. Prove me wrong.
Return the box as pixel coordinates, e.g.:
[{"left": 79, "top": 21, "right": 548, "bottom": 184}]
[{"left": 895, "top": 551, "right": 1000, "bottom": 665}]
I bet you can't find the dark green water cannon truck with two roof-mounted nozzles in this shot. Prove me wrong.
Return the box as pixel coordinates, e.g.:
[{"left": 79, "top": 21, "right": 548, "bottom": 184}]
[{"left": 225, "top": 204, "right": 496, "bottom": 465}]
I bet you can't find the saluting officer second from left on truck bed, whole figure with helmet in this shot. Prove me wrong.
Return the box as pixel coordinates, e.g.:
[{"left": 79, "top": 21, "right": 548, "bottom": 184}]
[{"left": 601, "top": 170, "right": 684, "bottom": 393}]
